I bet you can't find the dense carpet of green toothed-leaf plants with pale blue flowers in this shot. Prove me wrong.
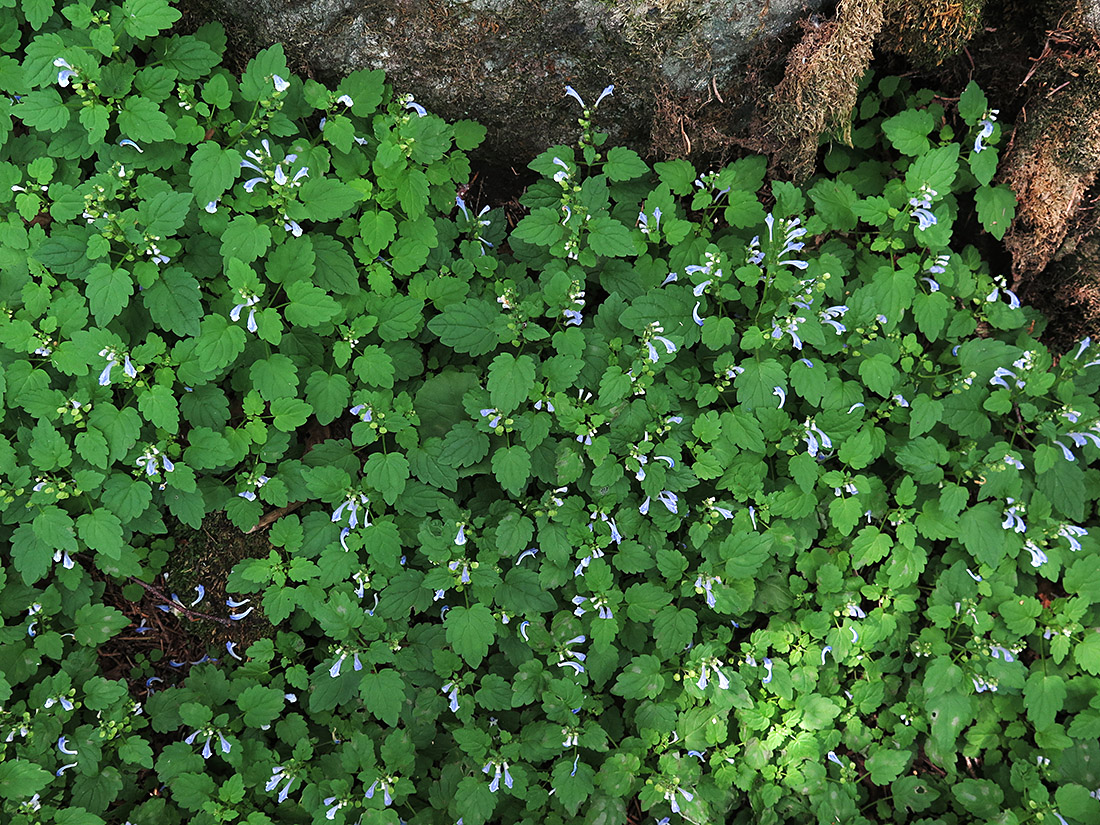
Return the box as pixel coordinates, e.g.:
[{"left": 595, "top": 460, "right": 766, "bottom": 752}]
[{"left": 0, "top": 0, "right": 1100, "bottom": 825}]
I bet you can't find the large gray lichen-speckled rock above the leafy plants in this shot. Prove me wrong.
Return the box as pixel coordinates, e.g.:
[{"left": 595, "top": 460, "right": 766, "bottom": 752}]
[{"left": 184, "top": 0, "right": 826, "bottom": 164}]
